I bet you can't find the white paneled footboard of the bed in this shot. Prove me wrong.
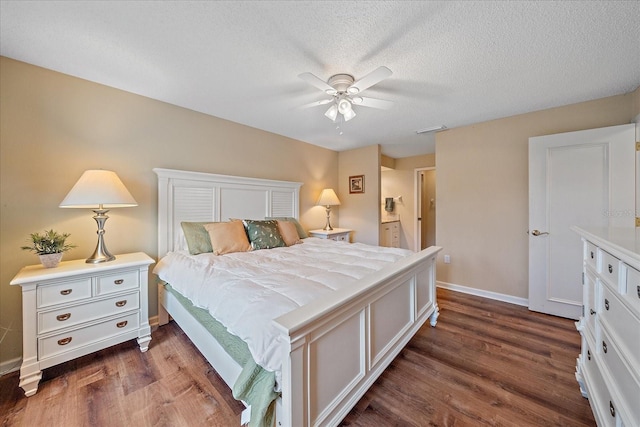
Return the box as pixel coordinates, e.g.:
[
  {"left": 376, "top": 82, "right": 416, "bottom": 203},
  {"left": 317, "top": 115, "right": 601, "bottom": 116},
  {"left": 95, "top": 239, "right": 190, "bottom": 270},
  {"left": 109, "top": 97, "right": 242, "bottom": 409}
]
[{"left": 275, "top": 246, "right": 441, "bottom": 426}]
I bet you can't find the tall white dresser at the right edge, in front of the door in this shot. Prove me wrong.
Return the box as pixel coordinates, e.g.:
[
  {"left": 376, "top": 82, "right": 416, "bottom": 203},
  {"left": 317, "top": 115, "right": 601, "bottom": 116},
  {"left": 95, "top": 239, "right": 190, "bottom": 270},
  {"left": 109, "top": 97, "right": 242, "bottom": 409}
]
[{"left": 573, "top": 227, "right": 640, "bottom": 427}]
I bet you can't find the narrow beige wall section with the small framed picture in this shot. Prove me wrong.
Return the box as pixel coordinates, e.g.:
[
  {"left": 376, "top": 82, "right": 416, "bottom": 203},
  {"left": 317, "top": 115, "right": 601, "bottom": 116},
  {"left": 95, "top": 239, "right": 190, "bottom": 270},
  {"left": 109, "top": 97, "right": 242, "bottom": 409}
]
[{"left": 338, "top": 145, "right": 381, "bottom": 245}]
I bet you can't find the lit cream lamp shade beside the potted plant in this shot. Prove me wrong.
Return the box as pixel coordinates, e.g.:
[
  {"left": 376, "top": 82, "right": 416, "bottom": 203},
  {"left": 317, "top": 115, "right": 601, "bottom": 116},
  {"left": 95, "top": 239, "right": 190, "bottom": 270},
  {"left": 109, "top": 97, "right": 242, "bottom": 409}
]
[{"left": 60, "top": 170, "right": 138, "bottom": 209}]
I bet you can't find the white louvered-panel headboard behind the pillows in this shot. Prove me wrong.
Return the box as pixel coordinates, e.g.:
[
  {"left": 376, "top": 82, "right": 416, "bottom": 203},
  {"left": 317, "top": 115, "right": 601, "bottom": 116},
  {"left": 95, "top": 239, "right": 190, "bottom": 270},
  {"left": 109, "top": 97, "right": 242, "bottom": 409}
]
[{"left": 153, "top": 168, "right": 302, "bottom": 257}]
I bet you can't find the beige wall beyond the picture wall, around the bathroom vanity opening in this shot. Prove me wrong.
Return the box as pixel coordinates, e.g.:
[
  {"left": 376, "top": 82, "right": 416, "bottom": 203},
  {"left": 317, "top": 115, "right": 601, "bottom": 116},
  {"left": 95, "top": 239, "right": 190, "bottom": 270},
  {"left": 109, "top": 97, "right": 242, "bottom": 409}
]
[{"left": 381, "top": 154, "right": 436, "bottom": 250}]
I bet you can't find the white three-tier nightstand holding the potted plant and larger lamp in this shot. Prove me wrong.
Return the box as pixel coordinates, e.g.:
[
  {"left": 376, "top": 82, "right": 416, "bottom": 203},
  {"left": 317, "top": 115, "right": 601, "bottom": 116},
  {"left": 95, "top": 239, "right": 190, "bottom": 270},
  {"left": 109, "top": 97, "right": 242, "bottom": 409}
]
[{"left": 10, "top": 252, "right": 154, "bottom": 396}]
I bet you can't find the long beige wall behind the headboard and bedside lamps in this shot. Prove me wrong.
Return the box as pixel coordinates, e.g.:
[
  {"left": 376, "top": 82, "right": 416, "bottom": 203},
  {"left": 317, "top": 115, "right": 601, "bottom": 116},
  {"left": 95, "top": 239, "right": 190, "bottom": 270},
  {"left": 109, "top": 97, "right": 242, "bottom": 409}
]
[{"left": 0, "top": 57, "right": 340, "bottom": 372}]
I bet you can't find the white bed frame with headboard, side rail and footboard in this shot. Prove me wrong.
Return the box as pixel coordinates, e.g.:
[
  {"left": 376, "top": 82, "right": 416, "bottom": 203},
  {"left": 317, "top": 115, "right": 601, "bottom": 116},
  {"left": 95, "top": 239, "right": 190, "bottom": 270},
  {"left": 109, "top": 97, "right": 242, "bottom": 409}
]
[{"left": 154, "top": 169, "right": 441, "bottom": 427}]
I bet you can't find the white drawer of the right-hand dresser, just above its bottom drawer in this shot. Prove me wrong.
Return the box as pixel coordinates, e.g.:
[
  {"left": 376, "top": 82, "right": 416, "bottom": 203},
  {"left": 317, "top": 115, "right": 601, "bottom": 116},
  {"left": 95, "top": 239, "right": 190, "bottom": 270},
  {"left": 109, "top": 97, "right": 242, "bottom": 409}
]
[{"left": 601, "top": 330, "right": 640, "bottom": 425}]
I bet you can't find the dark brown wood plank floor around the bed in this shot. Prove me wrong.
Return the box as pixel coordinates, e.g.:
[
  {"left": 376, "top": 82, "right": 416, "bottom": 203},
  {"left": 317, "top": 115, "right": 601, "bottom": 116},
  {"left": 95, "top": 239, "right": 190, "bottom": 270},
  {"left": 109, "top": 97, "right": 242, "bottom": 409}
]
[{"left": 0, "top": 289, "right": 595, "bottom": 427}]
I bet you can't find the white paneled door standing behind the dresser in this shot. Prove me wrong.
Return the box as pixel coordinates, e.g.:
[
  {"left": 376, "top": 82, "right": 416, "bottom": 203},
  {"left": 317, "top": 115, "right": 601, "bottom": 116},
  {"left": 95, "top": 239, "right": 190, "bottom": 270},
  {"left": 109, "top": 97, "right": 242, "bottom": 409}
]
[{"left": 529, "top": 124, "right": 636, "bottom": 319}]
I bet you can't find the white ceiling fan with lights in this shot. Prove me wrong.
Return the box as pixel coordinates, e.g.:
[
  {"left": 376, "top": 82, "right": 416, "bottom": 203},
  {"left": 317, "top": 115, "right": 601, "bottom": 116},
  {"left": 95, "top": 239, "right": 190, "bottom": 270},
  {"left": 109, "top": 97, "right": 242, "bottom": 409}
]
[{"left": 298, "top": 66, "right": 393, "bottom": 122}]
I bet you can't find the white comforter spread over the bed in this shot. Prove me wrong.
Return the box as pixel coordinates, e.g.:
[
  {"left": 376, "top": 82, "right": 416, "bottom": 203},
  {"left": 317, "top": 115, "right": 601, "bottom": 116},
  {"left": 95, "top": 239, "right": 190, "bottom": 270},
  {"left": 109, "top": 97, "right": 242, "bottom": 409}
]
[{"left": 154, "top": 238, "right": 413, "bottom": 379}]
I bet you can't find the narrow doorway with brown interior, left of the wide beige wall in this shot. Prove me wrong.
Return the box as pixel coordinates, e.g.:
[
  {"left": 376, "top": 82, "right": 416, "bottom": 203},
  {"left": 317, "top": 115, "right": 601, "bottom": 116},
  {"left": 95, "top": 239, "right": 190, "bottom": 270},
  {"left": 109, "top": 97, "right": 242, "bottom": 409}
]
[{"left": 414, "top": 167, "right": 436, "bottom": 251}]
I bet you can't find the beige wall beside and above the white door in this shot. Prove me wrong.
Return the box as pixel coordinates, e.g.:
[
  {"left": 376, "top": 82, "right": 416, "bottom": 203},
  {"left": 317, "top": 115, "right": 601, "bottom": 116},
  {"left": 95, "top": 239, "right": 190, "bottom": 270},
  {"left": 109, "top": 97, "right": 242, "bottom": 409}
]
[{"left": 436, "top": 91, "right": 638, "bottom": 298}]
